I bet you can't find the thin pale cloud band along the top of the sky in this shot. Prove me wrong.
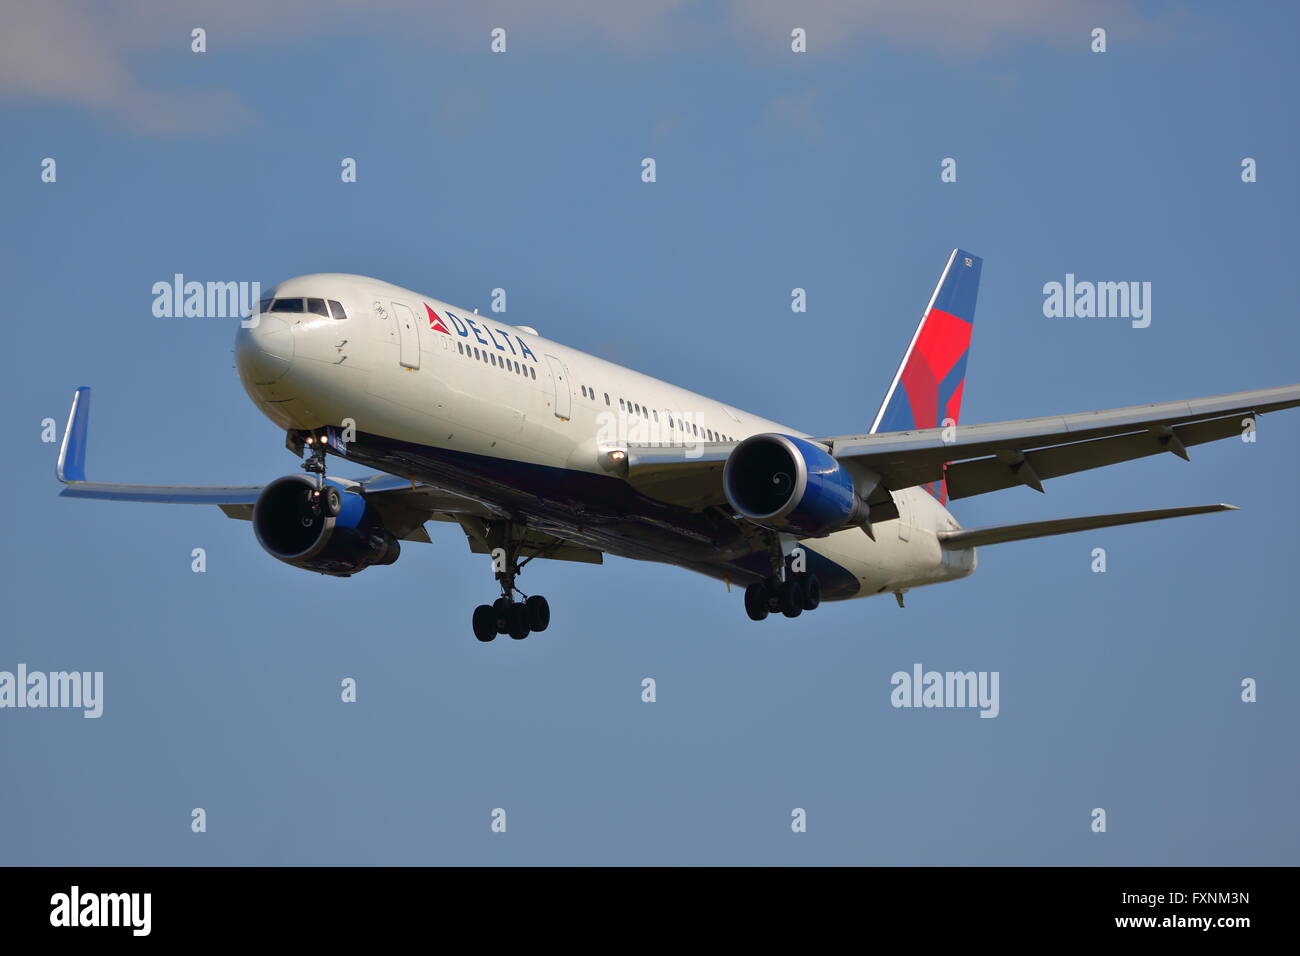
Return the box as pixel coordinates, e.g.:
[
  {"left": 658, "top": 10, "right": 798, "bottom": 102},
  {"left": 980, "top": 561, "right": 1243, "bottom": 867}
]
[{"left": 0, "top": 0, "right": 1159, "bottom": 133}]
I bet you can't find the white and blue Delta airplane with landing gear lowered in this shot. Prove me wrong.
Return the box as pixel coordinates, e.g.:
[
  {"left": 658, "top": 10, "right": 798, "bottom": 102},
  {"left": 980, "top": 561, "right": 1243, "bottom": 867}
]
[{"left": 56, "top": 248, "right": 1300, "bottom": 643}]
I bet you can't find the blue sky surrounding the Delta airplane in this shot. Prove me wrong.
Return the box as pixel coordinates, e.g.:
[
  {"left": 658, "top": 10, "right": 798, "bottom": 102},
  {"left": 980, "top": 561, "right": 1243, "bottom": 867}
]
[{"left": 0, "top": 0, "right": 1300, "bottom": 865}]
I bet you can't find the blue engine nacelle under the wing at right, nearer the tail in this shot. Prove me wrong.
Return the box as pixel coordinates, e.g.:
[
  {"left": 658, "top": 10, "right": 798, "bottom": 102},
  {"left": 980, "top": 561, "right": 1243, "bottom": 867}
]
[{"left": 723, "top": 433, "right": 868, "bottom": 537}]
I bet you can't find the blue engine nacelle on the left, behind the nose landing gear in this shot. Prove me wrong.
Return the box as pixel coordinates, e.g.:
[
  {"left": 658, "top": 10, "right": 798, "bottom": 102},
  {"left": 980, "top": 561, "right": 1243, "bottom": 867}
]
[{"left": 252, "top": 475, "right": 402, "bottom": 578}]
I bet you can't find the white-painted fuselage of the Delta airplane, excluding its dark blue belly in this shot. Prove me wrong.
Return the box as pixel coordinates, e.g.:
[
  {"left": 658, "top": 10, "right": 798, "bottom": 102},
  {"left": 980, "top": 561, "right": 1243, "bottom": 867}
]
[{"left": 237, "top": 274, "right": 975, "bottom": 597}]
